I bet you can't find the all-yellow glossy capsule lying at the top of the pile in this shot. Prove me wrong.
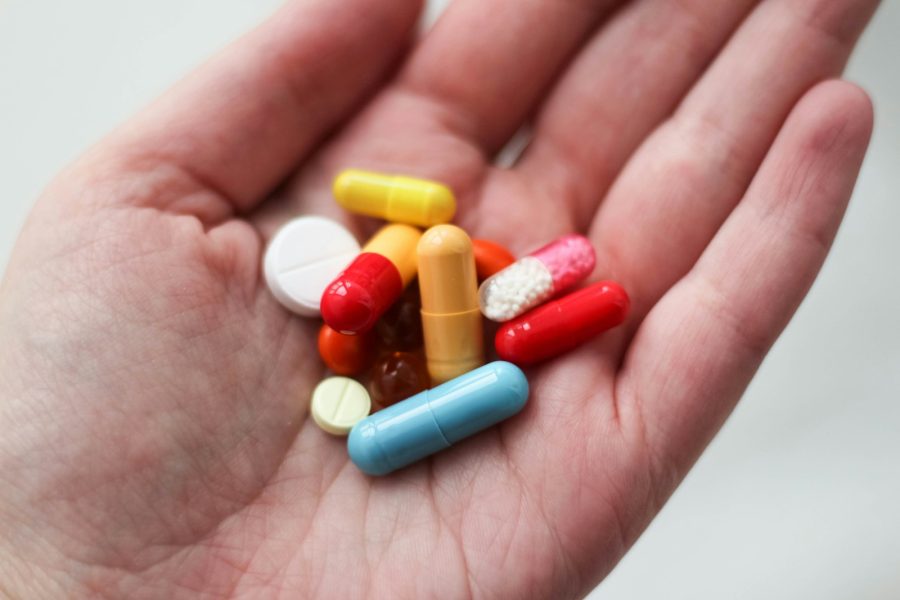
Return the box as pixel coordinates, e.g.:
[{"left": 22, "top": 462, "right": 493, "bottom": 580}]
[{"left": 333, "top": 169, "right": 456, "bottom": 227}]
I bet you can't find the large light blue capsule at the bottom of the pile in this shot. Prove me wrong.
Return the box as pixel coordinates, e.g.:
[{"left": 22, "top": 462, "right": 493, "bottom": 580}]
[{"left": 347, "top": 361, "right": 528, "bottom": 475}]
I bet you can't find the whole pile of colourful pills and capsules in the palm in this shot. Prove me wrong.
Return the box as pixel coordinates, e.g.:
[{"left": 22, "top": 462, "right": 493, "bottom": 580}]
[{"left": 264, "top": 170, "right": 629, "bottom": 475}]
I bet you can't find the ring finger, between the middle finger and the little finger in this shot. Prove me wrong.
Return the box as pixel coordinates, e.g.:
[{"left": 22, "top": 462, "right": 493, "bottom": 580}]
[{"left": 591, "top": 0, "right": 877, "bottom": 323}]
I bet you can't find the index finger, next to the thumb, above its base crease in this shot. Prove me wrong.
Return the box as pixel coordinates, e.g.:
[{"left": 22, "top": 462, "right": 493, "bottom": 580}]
[{"left": 398, "top": 0, "right": 616, "bottom": 155}]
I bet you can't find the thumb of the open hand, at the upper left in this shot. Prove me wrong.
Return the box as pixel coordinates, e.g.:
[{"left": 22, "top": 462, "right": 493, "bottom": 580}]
[{"left": 82, "top": 0, "right": 420, "bottom": 220}]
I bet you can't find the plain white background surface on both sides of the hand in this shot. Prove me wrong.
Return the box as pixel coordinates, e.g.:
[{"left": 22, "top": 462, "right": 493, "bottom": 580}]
[{"left": 0, "top": 0, "right": 900, "bottom": 600}]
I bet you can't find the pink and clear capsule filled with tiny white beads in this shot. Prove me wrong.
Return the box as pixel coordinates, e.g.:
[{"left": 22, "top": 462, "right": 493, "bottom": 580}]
[{"left": 478, "top": 234, "right": 596, "bottom": 322}]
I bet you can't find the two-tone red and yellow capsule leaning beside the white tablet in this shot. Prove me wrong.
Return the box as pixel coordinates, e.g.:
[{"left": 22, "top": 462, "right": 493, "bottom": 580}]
[{"left": 321, "top": 224, "right": 422, "bottom": 335}]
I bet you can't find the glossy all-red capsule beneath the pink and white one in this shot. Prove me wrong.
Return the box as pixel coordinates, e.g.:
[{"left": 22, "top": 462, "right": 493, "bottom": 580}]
[{"left": 494, "top": 281, "right": 630, "bottom": 367}]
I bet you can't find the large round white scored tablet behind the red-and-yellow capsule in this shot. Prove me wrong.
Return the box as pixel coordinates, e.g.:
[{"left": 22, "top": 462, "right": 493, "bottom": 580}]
[{"left": 263, "top": 217, "right": 359, "bottom": 317}]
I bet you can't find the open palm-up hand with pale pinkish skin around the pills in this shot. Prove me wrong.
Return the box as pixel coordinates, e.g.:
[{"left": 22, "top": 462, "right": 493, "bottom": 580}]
[{"left": 0, "top": 0, "right": 876, "bottom": 598}]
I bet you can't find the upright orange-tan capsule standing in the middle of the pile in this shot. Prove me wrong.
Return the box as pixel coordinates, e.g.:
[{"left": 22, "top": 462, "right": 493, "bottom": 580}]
[{"left": 418, "top": 225, "right": 484, "bottom": 383}]
